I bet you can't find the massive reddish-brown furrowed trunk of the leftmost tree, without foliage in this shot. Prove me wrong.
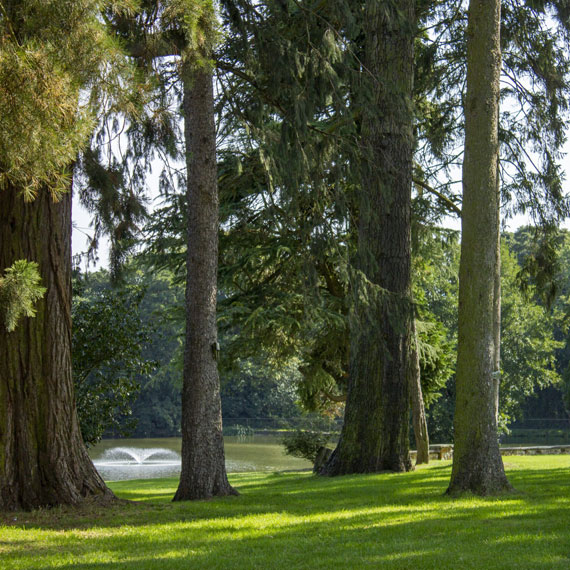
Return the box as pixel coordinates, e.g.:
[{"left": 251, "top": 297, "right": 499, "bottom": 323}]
[{"left": 0, "top": 188, "right": 114, "bottom": 510}]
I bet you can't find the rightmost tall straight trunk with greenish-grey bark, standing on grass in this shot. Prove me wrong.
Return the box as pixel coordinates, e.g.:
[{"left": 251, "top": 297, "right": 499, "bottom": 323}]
[{"left": 448, "top": 0, "right": 510, "bottom": 495}]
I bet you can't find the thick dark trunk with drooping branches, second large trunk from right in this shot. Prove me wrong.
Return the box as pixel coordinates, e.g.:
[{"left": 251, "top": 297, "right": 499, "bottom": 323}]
[{"left": 321, "top": 0, "right": 415, "bottom": 475}]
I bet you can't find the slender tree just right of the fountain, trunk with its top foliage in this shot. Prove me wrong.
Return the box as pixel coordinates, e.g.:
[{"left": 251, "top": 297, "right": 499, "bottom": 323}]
[{"left": 105, "top": 0, "right": 236, "bottom": 501}]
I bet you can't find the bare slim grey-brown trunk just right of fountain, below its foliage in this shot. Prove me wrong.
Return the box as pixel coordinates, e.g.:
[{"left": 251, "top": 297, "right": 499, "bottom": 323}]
[{"left": 174, "top": 69, "right": 237, "bottom": 501}]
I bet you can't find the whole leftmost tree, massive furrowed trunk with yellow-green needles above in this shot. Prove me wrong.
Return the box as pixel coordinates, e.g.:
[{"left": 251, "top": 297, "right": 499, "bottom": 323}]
[{"left": 0, "top": 0, "right": 125, "bottom": 510}]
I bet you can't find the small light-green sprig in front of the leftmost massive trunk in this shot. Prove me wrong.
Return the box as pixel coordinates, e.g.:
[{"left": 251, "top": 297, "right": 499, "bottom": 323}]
[{"left": 0, "top": 259, "right": 46, "bottom": 332}]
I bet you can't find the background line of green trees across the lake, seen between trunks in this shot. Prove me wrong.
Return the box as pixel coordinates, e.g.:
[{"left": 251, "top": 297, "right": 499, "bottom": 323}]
[{"left": 73, "top": 227, "right": 570, "bottom": 443}]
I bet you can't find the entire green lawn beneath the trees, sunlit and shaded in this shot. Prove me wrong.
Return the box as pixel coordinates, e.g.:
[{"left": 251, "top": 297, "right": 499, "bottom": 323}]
[{"left": 0, "top": 455, "right": 570, "bottom": 570}]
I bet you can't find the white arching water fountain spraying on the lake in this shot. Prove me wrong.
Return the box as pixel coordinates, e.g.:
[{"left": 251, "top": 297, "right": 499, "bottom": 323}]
[{"left": 93, "top": 447, "right": 180, "bottom": 481}]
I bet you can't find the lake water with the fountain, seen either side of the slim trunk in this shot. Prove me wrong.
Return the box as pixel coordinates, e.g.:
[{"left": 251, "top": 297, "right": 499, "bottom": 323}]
[{"left": 89, "top": 435, "right": 312, "bottom": 481}]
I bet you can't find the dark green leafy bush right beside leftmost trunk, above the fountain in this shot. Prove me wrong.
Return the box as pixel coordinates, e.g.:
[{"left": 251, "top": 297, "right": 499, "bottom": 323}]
[{"left": 72, "top": 270, "right": 154, "bottom": 445}]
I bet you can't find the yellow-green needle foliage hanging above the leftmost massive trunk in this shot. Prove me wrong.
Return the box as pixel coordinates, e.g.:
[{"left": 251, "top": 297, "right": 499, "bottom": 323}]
[{"left": 0, "top": 0, "right": 134, "bottom": 200}]
